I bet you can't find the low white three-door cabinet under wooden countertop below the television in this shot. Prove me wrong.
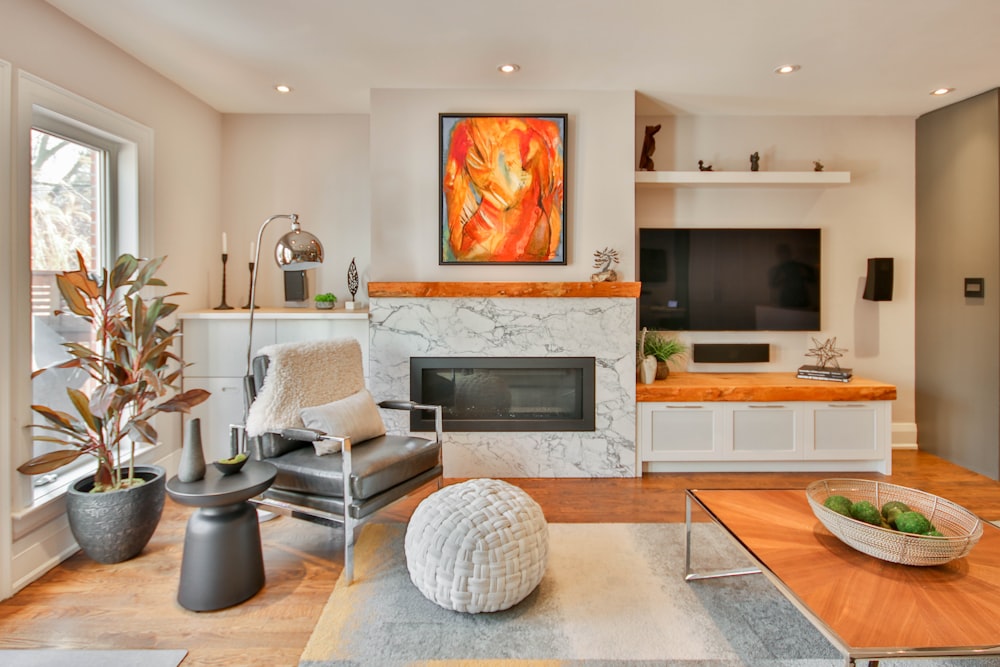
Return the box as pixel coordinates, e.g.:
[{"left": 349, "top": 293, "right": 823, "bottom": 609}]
[{"left": 638, "top": 401, "right": 892, "bottom": 473}]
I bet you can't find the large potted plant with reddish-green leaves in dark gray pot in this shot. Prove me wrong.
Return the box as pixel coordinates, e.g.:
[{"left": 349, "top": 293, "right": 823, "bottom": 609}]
[{"left": 18, "top": 253, "right": 209, "bottom": 563}]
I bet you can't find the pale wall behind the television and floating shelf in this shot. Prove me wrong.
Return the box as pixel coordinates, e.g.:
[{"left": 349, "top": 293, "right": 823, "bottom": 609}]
[{"left": 634, "top": 117, "right": 915, "bottom": 430}]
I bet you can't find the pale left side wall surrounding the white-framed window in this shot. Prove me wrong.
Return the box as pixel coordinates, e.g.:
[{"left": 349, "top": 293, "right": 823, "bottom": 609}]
[{"left": 0, "top": 0, "right": 221, "bottom": 597}]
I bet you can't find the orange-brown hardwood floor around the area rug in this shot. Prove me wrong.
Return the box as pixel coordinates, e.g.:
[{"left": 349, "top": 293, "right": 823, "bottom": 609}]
[{"left": 0, "top": 451, "right": 1000, "bottom": 667}]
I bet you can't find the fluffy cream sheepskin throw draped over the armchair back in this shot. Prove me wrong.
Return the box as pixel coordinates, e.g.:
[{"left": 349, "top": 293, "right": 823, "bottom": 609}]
[{"left": 247, "top": 338, "right": 365, "bottom": 437}]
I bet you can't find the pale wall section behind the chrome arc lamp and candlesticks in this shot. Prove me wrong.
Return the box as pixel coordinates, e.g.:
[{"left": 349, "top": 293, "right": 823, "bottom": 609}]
[{"left": 219, "top": 114, "right": 371, "bottom": 308}]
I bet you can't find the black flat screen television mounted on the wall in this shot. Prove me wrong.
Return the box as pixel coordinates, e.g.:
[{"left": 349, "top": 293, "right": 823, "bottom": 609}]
[{"left": 639, "top": 228, "right": 821, "bottom": 331}]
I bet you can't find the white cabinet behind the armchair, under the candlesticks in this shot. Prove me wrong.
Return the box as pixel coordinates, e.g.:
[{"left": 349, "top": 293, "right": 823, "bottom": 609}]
[{"left": 180, "top": 308, "right": 368, "bottom": 461}]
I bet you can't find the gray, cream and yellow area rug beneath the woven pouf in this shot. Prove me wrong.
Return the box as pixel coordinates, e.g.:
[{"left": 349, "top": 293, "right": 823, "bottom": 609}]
[{"left": 299, "top": 524, "right": 1000, "bottom": 667}]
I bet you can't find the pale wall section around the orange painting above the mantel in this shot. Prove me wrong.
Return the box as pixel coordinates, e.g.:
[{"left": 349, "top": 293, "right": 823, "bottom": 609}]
[{"left": 371, "top": 90, "right": 635, "bottom": 282}]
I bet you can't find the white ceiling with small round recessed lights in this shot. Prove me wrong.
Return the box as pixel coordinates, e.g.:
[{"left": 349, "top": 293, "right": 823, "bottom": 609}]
[{"left": 47, "top": 0, "right": 1000, "bottom": 116}]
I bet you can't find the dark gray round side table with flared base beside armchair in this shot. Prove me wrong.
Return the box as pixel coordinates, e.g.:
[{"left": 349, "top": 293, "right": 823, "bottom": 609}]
[{"left": 167, "top": 461, "right": 277, "bottom": 611}]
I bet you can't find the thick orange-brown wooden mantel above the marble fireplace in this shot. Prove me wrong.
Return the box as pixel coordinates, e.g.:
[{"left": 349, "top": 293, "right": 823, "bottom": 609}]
[{"left": 368, "top": 282, "right": 642, "bottom": 299}]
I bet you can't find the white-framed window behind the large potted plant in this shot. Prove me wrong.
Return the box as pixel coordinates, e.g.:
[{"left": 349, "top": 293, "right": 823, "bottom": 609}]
[{"left": 12, "top": 72, "right": 154, "bottom": 508}]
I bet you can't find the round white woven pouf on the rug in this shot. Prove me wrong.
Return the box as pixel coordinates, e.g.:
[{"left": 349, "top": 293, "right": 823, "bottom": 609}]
[{"left": 404, "top": 479, "right": 549, "bottom": 614}]
